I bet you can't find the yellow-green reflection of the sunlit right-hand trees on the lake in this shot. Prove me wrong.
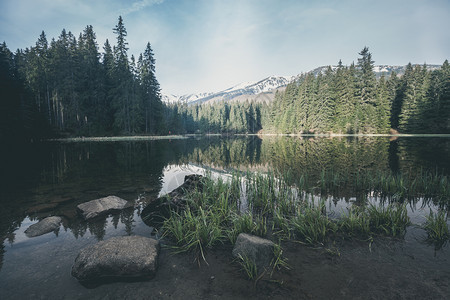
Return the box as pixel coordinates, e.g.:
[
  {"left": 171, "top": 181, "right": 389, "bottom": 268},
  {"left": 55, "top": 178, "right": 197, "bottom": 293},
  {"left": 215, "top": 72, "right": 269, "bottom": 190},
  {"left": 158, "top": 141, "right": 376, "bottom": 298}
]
[{"left": 179, "top": 137, "right": 389, "bottom": 182}]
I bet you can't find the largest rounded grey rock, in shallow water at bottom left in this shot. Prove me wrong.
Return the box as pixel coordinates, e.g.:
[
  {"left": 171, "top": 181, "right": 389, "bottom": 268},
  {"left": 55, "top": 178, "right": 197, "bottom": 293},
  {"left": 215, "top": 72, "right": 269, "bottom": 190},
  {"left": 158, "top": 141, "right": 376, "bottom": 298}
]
[{"left": 72, "top": 236, "right": 160, "bottom": 281}]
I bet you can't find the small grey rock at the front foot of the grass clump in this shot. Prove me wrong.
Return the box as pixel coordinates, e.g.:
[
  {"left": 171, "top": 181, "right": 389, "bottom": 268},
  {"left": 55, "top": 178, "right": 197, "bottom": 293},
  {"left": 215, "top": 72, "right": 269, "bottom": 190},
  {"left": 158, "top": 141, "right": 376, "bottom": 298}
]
[{"left": 232, "top": 233, "right": 275, "bottom": 269}]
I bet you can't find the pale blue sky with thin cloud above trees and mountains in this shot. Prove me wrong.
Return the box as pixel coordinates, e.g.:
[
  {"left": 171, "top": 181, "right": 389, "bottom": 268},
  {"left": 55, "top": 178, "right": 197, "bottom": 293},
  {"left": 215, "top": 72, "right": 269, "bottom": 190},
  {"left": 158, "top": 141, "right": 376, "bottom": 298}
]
[{"left": 0, "top": 0, "right": 450, "bottom": 95}]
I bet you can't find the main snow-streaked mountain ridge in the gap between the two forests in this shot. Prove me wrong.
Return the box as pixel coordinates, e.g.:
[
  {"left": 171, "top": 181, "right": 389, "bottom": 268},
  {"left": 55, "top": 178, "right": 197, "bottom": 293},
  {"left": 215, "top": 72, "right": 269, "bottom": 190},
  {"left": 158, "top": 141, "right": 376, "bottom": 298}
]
[{"left": 162, "top": 76, "right": 294, "bottom": 104}]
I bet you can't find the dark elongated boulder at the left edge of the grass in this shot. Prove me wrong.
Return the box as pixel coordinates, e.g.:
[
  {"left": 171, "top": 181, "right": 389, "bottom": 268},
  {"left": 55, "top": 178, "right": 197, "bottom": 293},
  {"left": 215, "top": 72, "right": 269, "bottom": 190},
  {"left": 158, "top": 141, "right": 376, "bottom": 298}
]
[{"left": 141, "top": 174, "right": 205, "bottom": 226}]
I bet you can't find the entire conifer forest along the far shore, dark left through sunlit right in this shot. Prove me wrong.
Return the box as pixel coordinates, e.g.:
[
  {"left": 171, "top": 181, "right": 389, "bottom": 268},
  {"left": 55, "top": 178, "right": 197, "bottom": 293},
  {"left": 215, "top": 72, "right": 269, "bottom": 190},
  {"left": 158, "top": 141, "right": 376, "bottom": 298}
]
[{"left": 0, "top": 17, "right": 450, "bottom": 140}]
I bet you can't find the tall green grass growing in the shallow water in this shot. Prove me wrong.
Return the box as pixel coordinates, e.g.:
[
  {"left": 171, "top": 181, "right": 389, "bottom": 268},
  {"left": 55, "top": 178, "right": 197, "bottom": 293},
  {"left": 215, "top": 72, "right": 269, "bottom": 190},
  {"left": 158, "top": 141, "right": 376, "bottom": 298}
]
[{"left": 161, "top": 171, "right": 450, "bottom": 261}]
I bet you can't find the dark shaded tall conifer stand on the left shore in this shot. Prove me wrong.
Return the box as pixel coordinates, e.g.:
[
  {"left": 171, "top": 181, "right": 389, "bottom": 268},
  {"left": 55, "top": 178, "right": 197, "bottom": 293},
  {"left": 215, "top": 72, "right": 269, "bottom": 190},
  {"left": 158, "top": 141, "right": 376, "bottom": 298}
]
[{"left": 0, "top": 17, "right": 165, "bottom": 136}]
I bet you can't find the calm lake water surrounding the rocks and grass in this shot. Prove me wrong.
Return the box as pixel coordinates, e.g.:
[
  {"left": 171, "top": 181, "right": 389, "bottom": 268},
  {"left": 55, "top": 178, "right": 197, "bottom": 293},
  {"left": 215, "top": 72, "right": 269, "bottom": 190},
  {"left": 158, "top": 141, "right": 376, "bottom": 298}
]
[{"left": 0, "top": 136, "right": 450, "bottom": 299}]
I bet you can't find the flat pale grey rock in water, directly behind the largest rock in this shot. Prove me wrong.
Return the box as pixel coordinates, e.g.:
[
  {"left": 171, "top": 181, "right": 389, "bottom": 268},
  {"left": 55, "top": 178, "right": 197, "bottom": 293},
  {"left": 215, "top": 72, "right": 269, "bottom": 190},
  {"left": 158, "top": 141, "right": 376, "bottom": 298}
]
[{"left": 77, "top": 196, "right": 131, "bottom": 220}]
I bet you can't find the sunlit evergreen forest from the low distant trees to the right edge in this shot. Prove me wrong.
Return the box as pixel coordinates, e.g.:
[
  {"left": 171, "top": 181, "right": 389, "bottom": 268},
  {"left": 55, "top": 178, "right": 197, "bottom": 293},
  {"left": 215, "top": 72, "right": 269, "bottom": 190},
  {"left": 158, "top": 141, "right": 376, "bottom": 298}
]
[{"left": 163, "top": 47, "right": 450, "bottom": 134}]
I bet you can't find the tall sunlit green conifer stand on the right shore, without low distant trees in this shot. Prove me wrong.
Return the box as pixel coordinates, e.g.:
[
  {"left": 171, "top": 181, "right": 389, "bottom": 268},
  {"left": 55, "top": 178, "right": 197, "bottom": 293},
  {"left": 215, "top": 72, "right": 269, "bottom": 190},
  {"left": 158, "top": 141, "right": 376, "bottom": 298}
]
[{"left": 264, "top": 47, "right": 450, "bottom": 133}]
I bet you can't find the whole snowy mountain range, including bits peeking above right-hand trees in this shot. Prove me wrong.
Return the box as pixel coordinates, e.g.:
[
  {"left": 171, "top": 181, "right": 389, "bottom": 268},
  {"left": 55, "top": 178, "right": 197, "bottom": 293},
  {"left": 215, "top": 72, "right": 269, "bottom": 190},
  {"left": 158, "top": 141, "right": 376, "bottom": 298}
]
[{"left": 162, "top": 65, "right": 440, "bottom": 104}]
